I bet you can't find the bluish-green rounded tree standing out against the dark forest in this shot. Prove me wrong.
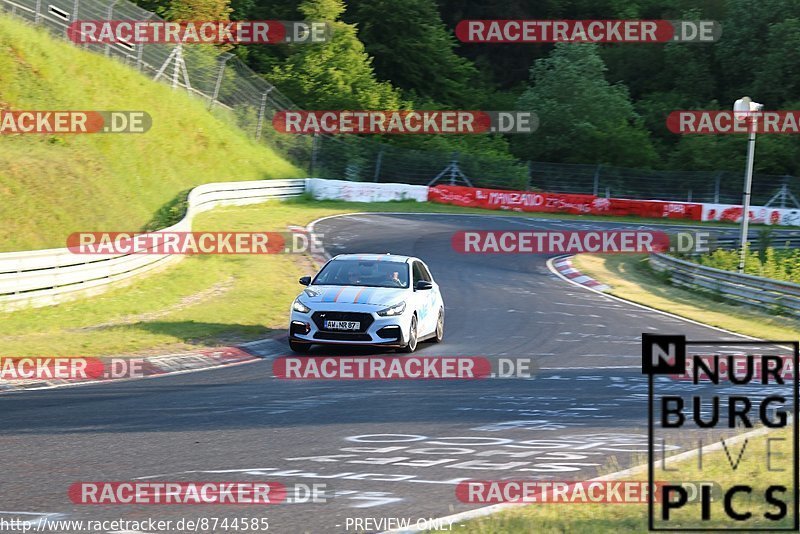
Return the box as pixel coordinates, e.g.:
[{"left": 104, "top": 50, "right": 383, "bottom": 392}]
[{"left": 512, "top": 43, "right": 657, "bottom": 167}]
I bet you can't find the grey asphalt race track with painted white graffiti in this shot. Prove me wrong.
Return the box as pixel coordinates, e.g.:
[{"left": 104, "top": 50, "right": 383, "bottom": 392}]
[{"left": 0, "top": 214, "right": 792, "bottom": 533}]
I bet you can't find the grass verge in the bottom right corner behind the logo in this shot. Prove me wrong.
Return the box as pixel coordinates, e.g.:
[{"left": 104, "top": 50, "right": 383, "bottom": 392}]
[{"left": 453, "top": 428, "right": 793, "bottom": 534}]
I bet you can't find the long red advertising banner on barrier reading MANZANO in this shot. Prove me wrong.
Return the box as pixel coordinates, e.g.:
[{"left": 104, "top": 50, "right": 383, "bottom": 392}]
[{"left": 428, "top": 185, "right": 703, "bottom": 221}]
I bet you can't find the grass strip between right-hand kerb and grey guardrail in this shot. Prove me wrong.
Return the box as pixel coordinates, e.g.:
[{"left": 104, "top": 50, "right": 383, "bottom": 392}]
[{"left": 573, "top": 254, "right": 800, "bottom": 339}]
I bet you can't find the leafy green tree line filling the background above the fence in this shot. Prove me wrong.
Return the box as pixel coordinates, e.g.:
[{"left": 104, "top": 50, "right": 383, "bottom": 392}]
[{"left": 130, "top": 0, "right": 800, "bottom": 181}]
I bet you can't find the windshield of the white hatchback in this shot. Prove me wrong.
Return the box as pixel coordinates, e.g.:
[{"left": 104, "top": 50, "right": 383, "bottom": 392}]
[{"left": 314, "top": 260, "right": 408, "bottom": 288}]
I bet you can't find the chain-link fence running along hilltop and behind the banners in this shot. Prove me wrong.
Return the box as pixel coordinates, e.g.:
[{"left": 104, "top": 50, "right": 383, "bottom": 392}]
[{"left": 0, "top": 0, "right": 800, "bottom": 207}]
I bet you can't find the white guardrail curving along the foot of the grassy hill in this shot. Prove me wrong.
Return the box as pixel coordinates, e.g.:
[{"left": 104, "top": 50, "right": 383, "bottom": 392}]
[{"left": 0, "top": 179, "right": 306, "bottom": 311}]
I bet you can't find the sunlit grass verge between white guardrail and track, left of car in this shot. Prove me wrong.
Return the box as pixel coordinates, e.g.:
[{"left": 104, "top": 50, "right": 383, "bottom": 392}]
[{"left": 0, "top": 201, "right": 356, "bottom": 356}]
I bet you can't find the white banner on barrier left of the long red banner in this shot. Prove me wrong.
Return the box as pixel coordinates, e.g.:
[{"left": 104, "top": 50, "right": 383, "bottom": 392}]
[{"left": 306, "top": 178, "right": 428, "bottom": 202}]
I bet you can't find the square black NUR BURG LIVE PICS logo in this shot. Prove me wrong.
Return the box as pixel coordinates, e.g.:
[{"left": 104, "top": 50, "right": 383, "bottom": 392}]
[{"left": 642, "top": 334, "right": 800, "bottom": 532}]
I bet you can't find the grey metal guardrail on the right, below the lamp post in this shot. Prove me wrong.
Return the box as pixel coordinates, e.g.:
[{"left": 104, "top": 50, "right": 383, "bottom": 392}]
[{"left": 650, "top": 254, "right": 800, "bottom": 317}]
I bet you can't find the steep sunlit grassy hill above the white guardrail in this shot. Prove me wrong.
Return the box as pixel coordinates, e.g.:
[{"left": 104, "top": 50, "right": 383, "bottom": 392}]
[{"left": 0, "top": 15, "right": 303, "bottom": 251}]
